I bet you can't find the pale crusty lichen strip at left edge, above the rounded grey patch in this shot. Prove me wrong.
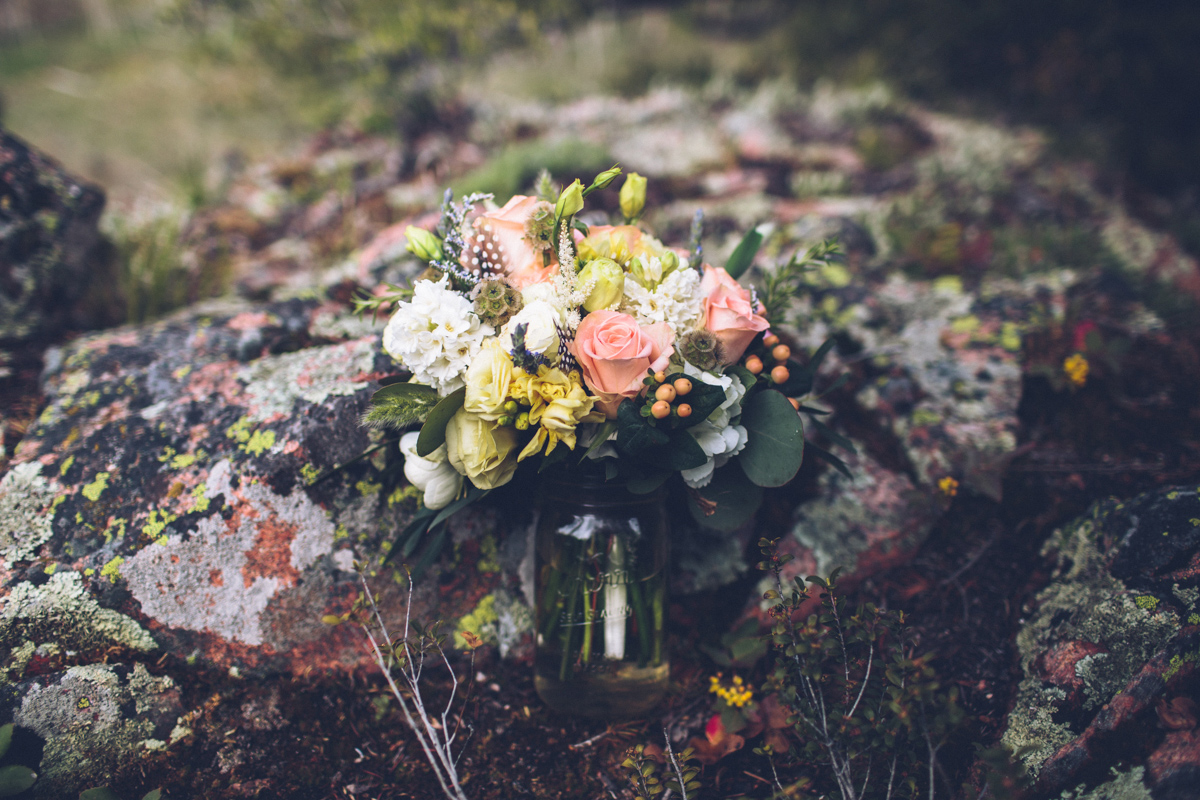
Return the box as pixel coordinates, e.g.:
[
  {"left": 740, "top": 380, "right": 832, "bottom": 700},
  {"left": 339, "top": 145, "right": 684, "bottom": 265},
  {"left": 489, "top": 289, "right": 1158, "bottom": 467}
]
[{"left": 0, "top": 572, "right": 157, "bottom": 652}]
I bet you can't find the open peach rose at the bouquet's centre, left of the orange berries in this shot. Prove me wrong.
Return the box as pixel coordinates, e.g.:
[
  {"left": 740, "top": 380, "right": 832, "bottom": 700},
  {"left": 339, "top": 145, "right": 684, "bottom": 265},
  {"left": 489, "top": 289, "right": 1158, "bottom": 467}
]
[{"left": 571, "top": 311, "right": 674, "bottom": 419}]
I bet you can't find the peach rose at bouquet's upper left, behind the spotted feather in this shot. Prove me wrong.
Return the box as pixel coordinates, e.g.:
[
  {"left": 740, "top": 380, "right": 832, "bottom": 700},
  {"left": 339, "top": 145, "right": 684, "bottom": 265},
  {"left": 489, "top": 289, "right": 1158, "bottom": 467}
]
[{"left": 462, "top": 194, "right": 558, "bottom": 289}]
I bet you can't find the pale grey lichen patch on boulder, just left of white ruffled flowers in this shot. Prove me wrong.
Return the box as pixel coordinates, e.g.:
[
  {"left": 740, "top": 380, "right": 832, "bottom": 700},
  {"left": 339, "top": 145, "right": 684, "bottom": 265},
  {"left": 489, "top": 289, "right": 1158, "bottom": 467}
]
[{"left": 239, "top": 337, "right": 378, "bottom": 422}]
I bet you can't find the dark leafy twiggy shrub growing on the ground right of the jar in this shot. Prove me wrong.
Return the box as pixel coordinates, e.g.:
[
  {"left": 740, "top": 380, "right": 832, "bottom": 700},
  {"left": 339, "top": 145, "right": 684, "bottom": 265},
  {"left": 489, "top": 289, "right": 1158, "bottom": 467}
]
[{"left": 758, "top": 539, "right": 964, "bottom": 800}]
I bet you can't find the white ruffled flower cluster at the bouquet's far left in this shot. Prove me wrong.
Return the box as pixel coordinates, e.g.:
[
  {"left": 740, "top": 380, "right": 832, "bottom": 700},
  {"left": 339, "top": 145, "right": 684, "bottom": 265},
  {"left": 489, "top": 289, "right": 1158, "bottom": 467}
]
[{"left": 383, "top": 276, "right": 496, "bottom": 396}]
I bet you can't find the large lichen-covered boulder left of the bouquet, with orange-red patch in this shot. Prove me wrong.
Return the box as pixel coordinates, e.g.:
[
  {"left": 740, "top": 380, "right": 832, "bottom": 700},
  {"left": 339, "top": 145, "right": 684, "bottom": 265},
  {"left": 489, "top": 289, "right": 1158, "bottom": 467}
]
[{"left": 0, "top": 300, "right": 517, "bottom": 679}]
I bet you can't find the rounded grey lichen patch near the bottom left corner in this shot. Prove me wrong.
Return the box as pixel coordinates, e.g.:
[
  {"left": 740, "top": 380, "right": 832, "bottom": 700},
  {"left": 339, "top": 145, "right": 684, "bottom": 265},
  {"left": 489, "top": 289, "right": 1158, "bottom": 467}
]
[{"left": 13, "top": 664, "right": 179, "bottom": 798}]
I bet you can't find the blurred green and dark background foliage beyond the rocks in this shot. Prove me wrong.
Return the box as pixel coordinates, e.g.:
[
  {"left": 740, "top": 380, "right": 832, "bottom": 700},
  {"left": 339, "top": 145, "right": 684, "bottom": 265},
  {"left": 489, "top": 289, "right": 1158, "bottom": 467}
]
[{"left": 0, "top": 0, "right": 1200, "bottom": 252}]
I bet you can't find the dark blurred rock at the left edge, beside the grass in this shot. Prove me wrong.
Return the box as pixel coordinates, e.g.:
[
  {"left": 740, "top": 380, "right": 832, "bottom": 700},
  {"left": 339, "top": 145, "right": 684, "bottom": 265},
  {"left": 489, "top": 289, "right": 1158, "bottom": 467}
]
[{"left": 0, "top": 130, "right": 106, "bottom": 344}]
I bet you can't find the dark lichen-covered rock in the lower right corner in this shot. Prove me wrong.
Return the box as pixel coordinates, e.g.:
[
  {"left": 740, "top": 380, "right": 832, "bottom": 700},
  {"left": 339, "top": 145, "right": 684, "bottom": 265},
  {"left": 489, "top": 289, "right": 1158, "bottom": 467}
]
[{"left": 1004, "top": 487, "right": 1200, "bottom": 798}]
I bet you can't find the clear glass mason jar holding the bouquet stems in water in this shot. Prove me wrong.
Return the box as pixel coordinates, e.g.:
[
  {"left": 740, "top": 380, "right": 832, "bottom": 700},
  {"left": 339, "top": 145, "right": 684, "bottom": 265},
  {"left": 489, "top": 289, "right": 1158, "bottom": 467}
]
[{"left": 534, "top": 474, "right": 670, "bottom": 718}]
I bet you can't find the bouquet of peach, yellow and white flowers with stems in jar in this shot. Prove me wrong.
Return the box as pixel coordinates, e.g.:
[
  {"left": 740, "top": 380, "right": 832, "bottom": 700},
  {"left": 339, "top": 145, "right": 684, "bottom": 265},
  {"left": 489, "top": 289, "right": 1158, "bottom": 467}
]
[{"left": 360, "top": 167, "right": 840, "bottom": 714}]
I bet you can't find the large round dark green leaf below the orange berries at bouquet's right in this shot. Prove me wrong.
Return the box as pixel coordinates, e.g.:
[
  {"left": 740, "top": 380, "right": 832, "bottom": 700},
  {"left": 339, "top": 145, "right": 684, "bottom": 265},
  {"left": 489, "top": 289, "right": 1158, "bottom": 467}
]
[{"left": 738, "top": 390, "right": 804, "bottom": 486}]
